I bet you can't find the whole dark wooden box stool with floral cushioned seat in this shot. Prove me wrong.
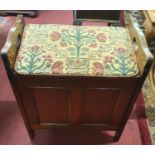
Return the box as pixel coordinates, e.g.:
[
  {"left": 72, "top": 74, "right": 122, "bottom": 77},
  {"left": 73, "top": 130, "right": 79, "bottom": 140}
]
[{"left": 1, "top": 16, "right": 153, "bottom": 141}]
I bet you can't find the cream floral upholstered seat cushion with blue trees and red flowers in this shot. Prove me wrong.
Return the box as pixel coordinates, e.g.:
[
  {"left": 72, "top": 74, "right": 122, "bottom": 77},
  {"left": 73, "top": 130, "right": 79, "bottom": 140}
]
[{"left": 14, "top": 24, "right": 138, "bottom": 77}]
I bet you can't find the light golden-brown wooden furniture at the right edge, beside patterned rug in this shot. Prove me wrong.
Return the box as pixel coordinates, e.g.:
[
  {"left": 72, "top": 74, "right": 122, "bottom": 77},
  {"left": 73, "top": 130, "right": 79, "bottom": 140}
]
[{"left": 143, "top": 10, "right": 155, "bottom": 106}]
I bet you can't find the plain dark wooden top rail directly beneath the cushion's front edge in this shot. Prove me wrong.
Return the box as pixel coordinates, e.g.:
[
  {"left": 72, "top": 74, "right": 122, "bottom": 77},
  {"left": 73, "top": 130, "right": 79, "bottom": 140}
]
[{"left": 15, "top": 74, "right": 140, "bottom": 88}]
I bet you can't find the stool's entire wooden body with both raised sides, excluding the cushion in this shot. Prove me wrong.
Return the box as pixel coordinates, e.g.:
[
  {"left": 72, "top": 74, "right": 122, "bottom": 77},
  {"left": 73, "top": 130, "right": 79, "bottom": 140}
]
[{"left": 1, "top": 16, "right": 153, "bottom": 141}]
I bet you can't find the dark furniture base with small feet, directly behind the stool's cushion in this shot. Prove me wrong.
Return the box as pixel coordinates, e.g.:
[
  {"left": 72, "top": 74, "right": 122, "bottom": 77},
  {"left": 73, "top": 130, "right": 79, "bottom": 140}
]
[{"left": 73, "top": 10, "right": 121, "bottom": 26}]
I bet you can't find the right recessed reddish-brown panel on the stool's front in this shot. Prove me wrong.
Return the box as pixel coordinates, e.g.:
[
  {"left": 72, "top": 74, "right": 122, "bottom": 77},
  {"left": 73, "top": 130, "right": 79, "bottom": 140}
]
[{"left": 81, "top": 88, "right": 121, "bottom": 124}]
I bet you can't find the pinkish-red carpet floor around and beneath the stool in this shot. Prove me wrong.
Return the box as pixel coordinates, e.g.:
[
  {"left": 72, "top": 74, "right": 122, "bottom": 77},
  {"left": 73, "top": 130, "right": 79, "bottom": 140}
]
[{"left": 0, "top": 11, "right": 151, "bottom": 144}]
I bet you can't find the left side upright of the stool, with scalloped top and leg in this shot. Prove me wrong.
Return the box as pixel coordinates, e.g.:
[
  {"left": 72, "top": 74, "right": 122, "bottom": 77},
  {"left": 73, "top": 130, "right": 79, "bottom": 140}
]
[{"left": 1, "top": 15, "right": 34, "bottom": 138}]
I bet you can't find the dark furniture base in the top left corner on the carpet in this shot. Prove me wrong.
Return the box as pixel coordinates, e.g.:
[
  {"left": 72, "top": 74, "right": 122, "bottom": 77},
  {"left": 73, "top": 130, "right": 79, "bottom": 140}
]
[{"left": 0, "top": 10, "right": 37, "bottom": 18}]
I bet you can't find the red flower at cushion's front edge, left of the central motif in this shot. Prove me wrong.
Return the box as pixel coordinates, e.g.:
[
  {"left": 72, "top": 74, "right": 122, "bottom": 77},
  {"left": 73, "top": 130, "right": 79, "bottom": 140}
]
[{"left": 52, "top": 61, "right": 63, "bottom": 74}]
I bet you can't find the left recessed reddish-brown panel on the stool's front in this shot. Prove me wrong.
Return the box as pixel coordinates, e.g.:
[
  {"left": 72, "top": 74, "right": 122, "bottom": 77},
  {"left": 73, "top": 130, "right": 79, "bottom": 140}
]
[{"left": 33, "top": 87, "right": 70, "bottom": 123}]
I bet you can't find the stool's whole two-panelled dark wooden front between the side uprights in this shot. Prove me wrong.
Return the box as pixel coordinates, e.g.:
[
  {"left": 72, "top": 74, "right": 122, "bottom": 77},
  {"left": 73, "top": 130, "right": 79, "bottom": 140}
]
[{"left": 16, "top": 74, "right": 138, "bottom": 130}]
